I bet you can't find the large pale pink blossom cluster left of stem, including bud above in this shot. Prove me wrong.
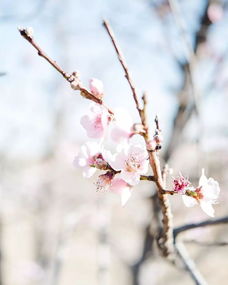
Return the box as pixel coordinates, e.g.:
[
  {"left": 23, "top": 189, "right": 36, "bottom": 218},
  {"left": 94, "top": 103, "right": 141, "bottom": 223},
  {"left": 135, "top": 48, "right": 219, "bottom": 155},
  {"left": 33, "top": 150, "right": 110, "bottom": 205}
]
[{"left": 74, "top": 79, "right": 148, "bottom": 205}]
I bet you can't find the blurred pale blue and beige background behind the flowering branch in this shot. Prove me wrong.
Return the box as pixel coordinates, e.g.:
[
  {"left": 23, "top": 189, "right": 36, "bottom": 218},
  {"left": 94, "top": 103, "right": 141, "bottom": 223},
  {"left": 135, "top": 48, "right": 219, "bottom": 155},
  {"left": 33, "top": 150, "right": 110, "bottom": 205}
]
[{"left": 0, "top": 0, "right": 228, "bottom": 285}]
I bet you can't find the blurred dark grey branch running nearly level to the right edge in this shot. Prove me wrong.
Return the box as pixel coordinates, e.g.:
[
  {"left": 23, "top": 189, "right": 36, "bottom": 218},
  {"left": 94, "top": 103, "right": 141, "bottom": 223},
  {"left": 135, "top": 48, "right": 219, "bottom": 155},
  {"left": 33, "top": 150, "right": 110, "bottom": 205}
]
[{"left": 173, "top": 216, "right": 228, "bottom": 239}]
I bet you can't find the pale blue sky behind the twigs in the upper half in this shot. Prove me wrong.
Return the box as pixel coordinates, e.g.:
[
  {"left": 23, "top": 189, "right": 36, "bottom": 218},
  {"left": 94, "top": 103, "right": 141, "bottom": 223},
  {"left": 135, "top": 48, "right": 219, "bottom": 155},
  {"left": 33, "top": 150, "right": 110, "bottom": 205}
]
[{"left": 0, "top": 0, "right": 227, "bottom": 159}]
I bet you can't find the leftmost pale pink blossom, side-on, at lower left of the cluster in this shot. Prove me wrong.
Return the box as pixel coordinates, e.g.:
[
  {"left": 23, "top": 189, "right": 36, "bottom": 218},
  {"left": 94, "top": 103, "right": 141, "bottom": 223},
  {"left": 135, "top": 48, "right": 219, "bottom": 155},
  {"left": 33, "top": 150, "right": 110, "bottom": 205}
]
[{"left": 74, "top": 142, "right": 104, "bottom": 178}]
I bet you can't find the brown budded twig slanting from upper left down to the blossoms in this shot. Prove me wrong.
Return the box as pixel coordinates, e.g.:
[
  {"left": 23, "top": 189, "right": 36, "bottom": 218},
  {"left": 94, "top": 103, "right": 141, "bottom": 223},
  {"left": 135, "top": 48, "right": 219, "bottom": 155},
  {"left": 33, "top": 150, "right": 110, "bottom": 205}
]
[{"left": 19, "top": 26, "right": 113, "bottom": 115}]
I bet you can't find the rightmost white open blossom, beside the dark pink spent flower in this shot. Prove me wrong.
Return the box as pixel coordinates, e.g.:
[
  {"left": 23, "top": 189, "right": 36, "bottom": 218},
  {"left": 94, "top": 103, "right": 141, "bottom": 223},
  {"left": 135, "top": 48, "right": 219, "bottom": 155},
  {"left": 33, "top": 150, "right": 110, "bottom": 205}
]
[{"left": 183, "top": 170, "right": 220, "bottom": 217}]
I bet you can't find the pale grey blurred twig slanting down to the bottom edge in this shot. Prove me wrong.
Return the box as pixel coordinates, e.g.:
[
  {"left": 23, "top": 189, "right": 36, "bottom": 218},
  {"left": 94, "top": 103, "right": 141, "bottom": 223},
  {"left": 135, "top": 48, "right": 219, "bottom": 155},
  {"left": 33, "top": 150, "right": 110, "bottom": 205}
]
[{"left": 175, "top": 242, "right": 207, "bottom": 285}]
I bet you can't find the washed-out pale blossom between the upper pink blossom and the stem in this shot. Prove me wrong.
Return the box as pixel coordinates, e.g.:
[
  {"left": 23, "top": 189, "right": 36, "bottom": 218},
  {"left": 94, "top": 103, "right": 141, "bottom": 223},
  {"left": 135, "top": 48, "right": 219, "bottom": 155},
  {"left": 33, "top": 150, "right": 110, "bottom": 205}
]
[{"left": 111, "top": 109, "right": 133, "bottom": 143}]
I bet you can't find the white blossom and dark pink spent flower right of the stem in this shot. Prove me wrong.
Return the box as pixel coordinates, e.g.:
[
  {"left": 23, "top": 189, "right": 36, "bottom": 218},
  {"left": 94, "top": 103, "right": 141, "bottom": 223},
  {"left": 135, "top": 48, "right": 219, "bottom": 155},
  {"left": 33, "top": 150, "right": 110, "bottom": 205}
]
[{"left": 173, "top": 169, "right": 220, "bottom": 217}]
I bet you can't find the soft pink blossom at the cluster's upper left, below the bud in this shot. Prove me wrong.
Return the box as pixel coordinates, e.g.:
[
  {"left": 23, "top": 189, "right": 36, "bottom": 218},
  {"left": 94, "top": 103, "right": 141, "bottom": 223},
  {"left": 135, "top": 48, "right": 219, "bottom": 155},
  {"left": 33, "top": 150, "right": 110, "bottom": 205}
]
[{"left": 80, "top": 104, "right": 110, "bottom": 139}]
